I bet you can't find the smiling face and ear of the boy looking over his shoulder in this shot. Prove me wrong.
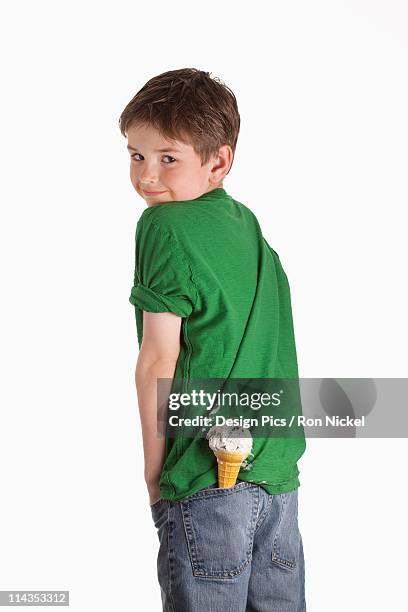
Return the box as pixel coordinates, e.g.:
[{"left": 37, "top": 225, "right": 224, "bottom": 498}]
[{"left": 127, "top": 125, "right": 228, "bottom": 206}]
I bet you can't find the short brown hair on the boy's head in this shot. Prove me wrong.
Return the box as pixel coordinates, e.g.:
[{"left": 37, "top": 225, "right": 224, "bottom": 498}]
[{"left": 119, "top": 68, "right": 240, "bottom": 169}]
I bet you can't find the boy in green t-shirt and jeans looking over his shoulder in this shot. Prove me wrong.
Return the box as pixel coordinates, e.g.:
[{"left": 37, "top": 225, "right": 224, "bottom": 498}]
[{"left": 119, "top": 68, "right": 306, "bottom": 612}]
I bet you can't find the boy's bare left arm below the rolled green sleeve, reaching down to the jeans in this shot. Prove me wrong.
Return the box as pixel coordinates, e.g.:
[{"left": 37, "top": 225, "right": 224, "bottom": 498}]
[{"left": 135, "top": 311, "right": 181, "bottom": 504}]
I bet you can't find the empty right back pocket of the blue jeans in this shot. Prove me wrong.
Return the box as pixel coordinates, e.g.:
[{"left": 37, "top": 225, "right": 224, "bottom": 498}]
[{"left": 271, "top": 489, "right": 300, "bottom": 569}]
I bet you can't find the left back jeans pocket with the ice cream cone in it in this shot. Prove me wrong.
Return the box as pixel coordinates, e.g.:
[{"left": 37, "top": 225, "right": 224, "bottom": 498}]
[{"left": 180, "top": 481, "right": 259, "bottom": 579}]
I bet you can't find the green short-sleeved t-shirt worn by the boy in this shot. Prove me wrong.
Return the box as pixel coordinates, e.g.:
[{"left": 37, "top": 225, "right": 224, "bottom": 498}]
[{"left": 129, "top": 188, "right": 306, "bottom": 501}]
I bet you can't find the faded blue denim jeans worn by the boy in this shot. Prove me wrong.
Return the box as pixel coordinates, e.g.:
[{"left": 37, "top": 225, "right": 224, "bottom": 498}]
[{"left": 150, "top": 481, "right": 306, "bottom": 612}]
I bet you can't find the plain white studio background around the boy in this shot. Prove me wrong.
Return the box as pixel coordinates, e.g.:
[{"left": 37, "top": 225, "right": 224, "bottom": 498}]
[{"left": 0, "top": 0, "right": 408, "bottom": 612}]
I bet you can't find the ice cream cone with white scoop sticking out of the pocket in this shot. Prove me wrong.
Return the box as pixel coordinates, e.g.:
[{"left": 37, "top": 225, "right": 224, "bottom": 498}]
[{"left": 206, "top": 425, "right": 252, "bottom": 489}]
